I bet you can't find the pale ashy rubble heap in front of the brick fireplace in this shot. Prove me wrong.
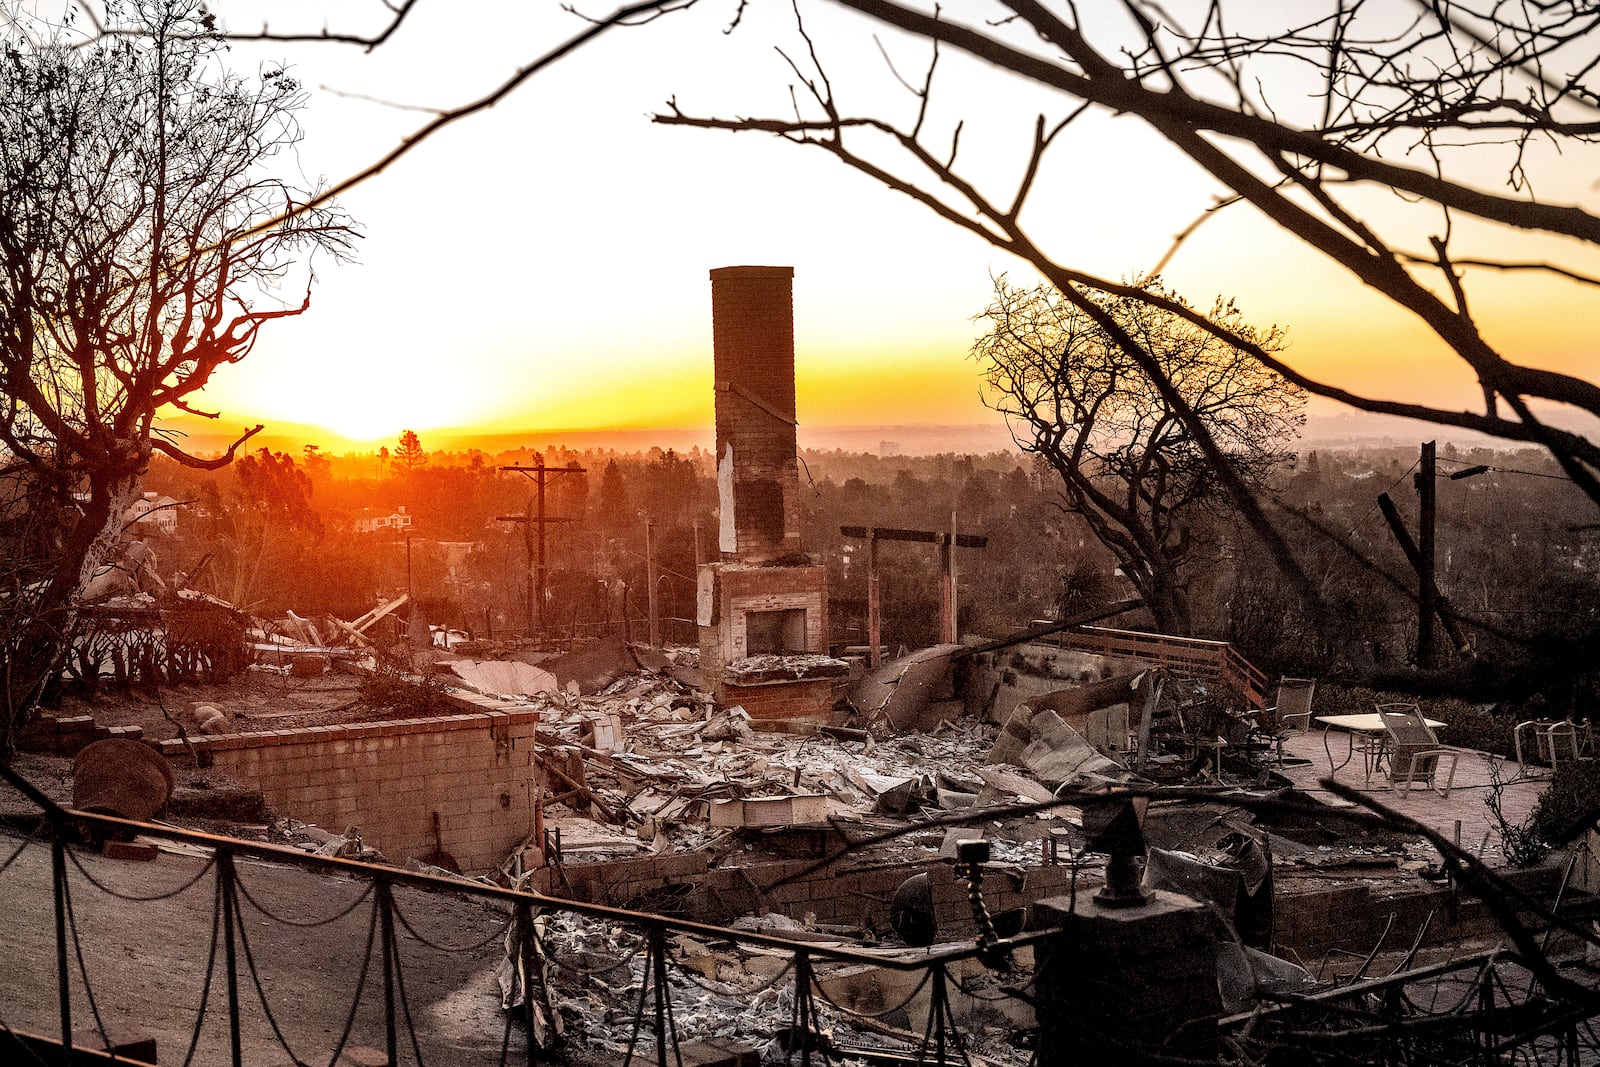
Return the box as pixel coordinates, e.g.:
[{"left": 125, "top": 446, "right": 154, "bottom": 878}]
[{"left": 492, "top": 673, "right": 1094, "bottom": 878}]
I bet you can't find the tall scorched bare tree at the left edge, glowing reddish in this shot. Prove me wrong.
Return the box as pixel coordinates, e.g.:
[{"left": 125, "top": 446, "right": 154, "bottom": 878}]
[{"left": 0, "top": 0, "right": 350, "bottom": 750}]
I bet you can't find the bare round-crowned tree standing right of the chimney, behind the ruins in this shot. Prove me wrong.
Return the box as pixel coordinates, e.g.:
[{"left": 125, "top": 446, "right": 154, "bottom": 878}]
[{"left": 973, "top": 275, "right": 1306, "bottom": 633}]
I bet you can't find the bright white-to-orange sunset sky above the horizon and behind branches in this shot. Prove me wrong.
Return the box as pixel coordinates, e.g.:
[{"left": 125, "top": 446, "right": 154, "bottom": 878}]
[{"left": 190, "top": 3, "right": 1600, "bottom": 451}]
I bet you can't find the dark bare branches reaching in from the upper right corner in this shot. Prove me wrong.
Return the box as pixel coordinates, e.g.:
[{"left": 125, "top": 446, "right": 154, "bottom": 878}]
[{"left": 643, "top": 0, "right": 1600, "bottom": 639}]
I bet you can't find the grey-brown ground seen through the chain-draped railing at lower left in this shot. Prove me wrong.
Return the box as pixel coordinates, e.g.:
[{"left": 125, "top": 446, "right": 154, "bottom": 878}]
[{"left": 0, "top": 830, "right": 525, "bottom": 1067}]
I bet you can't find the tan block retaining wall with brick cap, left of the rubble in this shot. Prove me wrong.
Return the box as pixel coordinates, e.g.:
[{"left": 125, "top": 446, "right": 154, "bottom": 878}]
[{"left": 162, "top": 710, "right": 539, "bottom": 873}]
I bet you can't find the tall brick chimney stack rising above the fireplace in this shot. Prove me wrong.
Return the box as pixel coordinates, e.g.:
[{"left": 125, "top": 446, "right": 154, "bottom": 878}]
[{"left": 710, "top": 267, "right": 800, "bottom": 563}]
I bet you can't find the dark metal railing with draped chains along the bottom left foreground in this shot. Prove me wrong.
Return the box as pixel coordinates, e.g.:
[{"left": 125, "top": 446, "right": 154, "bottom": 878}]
[{"left": 0, "top": 763, "right": 1046, "bottom": 1067}]
